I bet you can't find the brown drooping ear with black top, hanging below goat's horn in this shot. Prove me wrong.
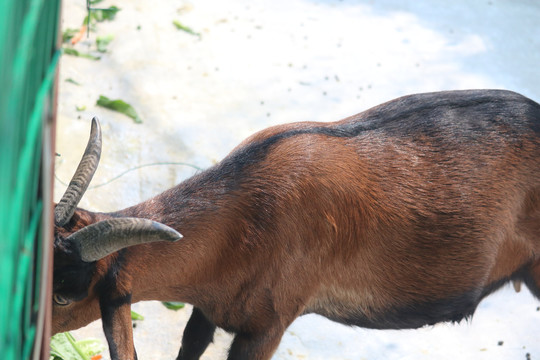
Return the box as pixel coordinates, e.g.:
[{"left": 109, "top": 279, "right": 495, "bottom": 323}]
[{"left": 99, "top": 294, "right": 137, "bottom": 360}]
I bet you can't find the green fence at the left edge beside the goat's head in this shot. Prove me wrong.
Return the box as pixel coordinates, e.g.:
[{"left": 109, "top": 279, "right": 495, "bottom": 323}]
[{"left": 0, "top": 0, "right": 60, "bottom": 360}]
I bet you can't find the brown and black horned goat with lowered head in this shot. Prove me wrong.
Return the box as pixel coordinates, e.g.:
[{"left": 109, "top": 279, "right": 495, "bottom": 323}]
[{"left": 52, "top": 90, "right": 540, "bottom": 360}]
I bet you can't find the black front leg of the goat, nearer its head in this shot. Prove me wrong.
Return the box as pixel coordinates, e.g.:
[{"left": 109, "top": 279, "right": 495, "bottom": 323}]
[{"left": 176, "top": 307, "right": 216, "bottom": 360}]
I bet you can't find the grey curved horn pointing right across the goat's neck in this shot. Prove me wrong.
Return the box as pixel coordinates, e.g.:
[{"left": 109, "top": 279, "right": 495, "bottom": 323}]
[{"left": 67, "top": 218, "right": 183, "bottom": 262}]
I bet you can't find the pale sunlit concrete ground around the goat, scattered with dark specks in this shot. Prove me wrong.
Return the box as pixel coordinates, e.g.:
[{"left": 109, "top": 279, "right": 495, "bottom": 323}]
[{"left": 55, "top": 0, "right": 540, "bottom": 360}]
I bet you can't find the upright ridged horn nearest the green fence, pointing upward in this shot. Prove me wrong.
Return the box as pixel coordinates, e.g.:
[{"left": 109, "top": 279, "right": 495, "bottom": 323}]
[{"left": 54, "top": 117, "right": 101, "bottom": 226}]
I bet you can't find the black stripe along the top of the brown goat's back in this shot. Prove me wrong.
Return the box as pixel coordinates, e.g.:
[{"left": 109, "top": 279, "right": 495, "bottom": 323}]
[{"left": 214, "top": 90, "right": 540, "bottom": 183}]
